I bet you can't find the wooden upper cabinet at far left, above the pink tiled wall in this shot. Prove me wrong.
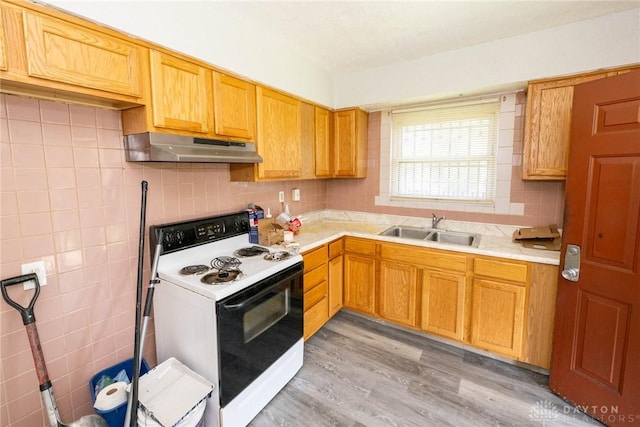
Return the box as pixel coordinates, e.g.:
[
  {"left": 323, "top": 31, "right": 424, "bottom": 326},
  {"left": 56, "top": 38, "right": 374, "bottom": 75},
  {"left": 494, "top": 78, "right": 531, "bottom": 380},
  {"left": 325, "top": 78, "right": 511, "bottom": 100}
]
[{"left": 0, "top": 2, "right": 144, "bottom": 107}]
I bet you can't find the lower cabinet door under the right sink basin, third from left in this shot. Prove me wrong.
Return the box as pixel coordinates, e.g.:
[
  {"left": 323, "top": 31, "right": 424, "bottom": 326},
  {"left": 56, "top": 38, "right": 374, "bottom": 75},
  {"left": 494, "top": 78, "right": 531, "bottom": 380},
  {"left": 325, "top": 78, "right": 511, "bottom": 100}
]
[{"left": 421, "top": 270, "right": 466, "bottom": 341}]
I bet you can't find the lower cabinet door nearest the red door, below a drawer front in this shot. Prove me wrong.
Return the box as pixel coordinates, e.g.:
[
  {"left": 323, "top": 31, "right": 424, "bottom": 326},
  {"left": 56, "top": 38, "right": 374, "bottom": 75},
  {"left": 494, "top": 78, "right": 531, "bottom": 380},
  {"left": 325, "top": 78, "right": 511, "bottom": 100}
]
[{"left": 471, "top": 279, "right": 526, "bottom": 359}]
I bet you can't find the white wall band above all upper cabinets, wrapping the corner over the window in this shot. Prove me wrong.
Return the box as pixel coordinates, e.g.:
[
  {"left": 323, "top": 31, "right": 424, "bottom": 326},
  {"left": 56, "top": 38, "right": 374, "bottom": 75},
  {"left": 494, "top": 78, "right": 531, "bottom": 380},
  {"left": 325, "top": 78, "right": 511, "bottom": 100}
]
[{"left": 45, "top": 0, "right": 640, "bottom": 109}]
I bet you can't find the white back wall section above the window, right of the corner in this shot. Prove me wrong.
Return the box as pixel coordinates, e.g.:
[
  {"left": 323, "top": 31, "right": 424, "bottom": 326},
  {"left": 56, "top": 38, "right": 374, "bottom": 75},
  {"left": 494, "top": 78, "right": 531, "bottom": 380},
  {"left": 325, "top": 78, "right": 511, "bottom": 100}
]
[{"left": 334, "top": 9, "right": 640, "bottom": 109}]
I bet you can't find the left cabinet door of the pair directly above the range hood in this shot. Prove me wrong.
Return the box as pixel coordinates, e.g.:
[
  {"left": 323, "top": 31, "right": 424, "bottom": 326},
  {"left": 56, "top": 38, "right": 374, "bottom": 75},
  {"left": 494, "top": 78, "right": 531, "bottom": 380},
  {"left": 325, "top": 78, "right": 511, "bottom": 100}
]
[{"left": 149, "top": 50, "right": 213, "bottom": 133}]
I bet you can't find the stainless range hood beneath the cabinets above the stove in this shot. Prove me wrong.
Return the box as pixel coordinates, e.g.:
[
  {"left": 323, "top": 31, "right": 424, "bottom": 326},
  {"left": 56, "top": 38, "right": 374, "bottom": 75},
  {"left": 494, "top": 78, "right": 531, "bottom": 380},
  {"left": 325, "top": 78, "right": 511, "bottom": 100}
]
[{"left": 124, "top": 132, "right": 262, "bottom": 163}]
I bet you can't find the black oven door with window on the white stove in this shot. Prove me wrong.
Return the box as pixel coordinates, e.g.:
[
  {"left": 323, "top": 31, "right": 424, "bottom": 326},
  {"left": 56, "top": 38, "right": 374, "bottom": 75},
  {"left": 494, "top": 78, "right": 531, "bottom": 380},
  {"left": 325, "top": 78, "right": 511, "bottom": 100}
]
[{"left": 217, "top": 262, "right": 303, "bottom": 407}]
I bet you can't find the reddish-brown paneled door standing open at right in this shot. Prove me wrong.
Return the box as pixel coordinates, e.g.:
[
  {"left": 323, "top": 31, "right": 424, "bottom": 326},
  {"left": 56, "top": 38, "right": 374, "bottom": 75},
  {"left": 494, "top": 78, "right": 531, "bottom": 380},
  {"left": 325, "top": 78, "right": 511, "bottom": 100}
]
[{"left": 550, "top": 71, "right": 640, "bottom": 426}]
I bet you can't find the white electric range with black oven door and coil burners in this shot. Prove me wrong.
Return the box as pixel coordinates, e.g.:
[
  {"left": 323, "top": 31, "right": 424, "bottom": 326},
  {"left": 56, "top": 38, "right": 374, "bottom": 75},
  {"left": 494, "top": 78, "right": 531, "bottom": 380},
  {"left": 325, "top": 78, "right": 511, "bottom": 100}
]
[{"left": 150, "top": 212, "right": 303, "bottom": 427}]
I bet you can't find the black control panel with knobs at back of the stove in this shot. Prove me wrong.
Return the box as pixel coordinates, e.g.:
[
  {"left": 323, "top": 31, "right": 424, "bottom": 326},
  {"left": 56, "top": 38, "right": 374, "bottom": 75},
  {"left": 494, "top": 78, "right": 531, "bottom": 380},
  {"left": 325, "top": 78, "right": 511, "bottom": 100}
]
[{"left": 149, "top": 211, "right": 249, "bottom": 253}]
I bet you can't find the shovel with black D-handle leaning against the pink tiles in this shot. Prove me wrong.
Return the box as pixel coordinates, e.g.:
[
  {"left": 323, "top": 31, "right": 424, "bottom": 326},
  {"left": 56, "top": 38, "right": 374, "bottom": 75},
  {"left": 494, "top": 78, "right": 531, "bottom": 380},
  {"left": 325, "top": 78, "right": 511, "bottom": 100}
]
[{"left": 0, "top": 273, "right": 109, "bottom": 427}]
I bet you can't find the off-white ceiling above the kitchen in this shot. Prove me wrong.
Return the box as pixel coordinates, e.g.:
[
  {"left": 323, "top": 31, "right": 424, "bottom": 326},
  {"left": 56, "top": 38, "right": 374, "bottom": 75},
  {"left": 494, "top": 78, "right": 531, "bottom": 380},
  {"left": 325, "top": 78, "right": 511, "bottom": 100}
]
[{"left": 211, "top": 0, "right": 640, "bottom": 76}]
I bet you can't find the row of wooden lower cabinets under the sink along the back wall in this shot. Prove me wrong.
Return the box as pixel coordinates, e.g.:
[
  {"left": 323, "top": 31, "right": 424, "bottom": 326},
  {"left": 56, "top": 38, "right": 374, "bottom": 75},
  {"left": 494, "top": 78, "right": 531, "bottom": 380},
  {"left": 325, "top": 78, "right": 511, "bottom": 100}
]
[{"left": 343, "top": 237, "right": 558, "bottom": 368}]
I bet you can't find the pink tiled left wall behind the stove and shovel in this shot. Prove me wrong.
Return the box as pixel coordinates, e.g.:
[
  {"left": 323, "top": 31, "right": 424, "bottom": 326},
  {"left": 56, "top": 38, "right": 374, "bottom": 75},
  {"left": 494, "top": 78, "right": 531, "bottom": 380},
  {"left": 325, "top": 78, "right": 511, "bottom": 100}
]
[{"left": 0, "top": 94, "right": 326, "bottom": 427}]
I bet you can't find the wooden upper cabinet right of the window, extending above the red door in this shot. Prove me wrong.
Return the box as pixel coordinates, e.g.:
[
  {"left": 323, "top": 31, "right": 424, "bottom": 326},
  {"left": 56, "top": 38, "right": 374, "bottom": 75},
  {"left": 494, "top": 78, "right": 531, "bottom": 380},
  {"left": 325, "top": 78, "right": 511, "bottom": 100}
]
[{"left": 522, "top": 67, "right": 632, "bottom": 180}]
